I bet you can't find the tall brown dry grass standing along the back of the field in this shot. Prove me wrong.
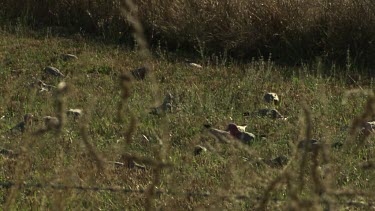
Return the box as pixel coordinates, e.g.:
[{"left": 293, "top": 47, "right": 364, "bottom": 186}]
[{"left": 0, "top": 0, "right": 375, "bottom": 66}]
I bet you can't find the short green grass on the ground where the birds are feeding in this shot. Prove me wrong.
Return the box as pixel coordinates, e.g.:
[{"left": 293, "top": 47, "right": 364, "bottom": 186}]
[{"left": 0, "top": 27, "right": 375, "bottom": 210}]
